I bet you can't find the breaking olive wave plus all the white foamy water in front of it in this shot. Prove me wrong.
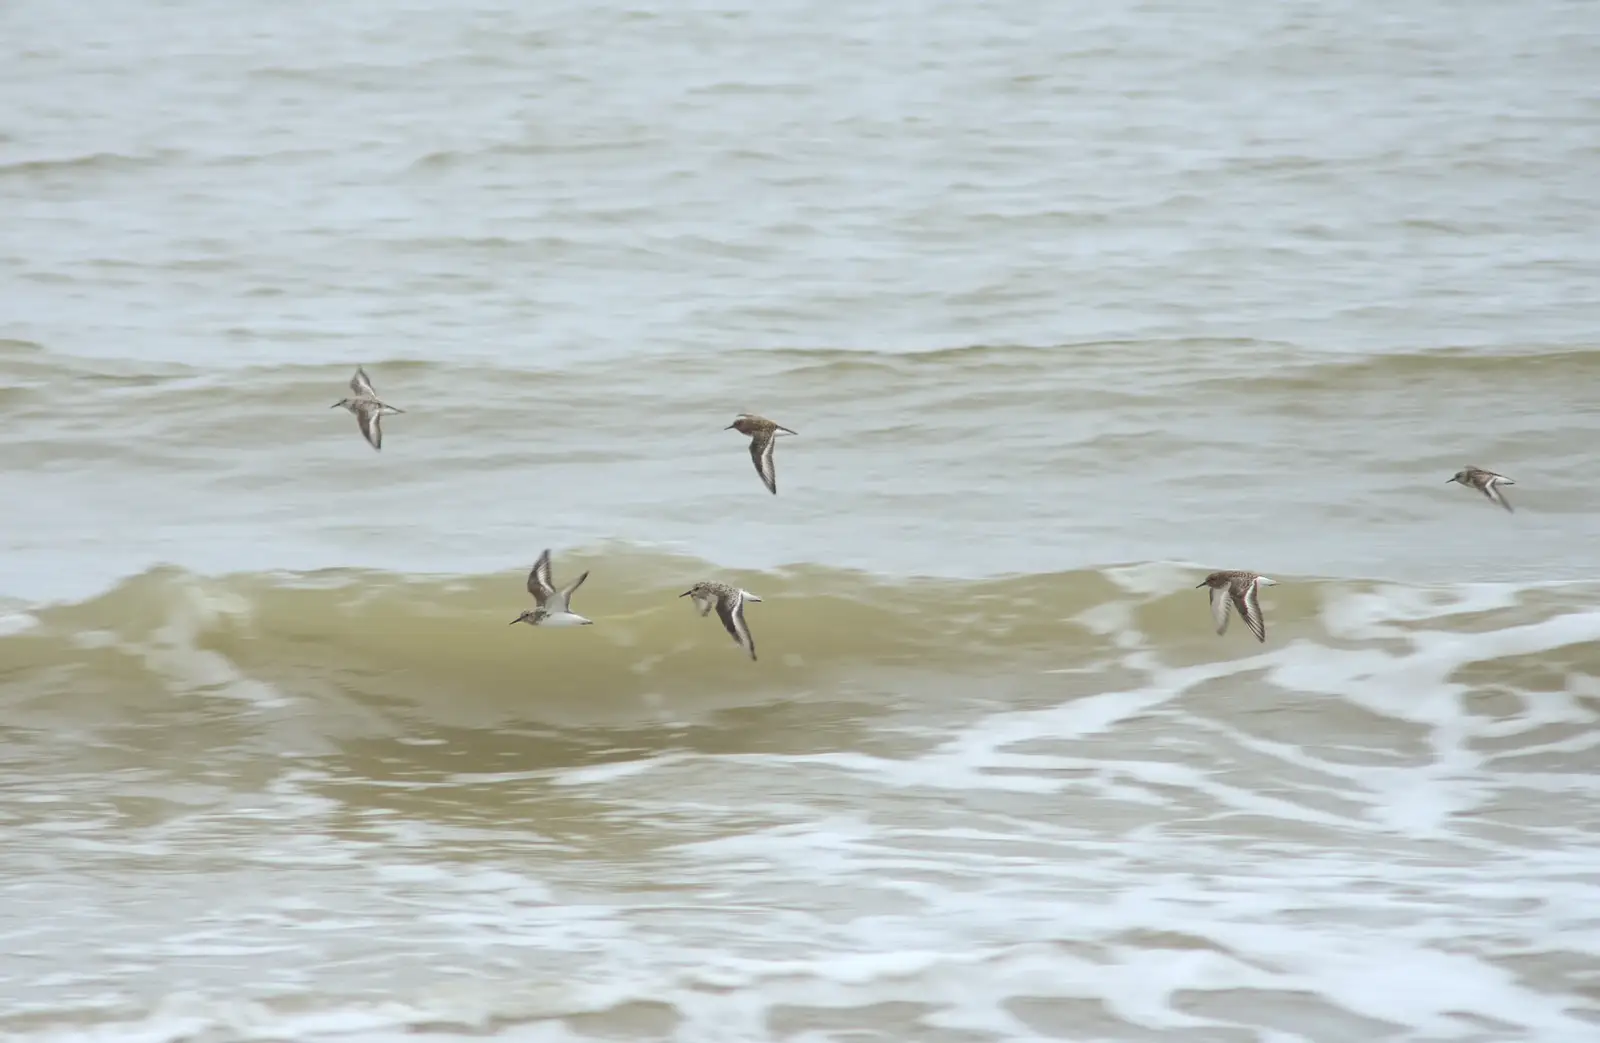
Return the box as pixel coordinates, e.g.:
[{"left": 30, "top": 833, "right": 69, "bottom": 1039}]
[{"left": 9, "top": 555, "right": 1600, "bottom": 1043}]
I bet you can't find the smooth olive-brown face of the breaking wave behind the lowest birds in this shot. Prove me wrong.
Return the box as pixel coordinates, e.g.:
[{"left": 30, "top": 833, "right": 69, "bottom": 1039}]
[{"left": 9, "top": 547, "right": 1600, "bottom": 723}]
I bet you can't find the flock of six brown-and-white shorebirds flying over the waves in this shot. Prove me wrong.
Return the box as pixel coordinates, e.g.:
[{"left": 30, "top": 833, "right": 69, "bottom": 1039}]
[{"left": 330, "top": 368, "right": 1517, "bottom": 659}]
